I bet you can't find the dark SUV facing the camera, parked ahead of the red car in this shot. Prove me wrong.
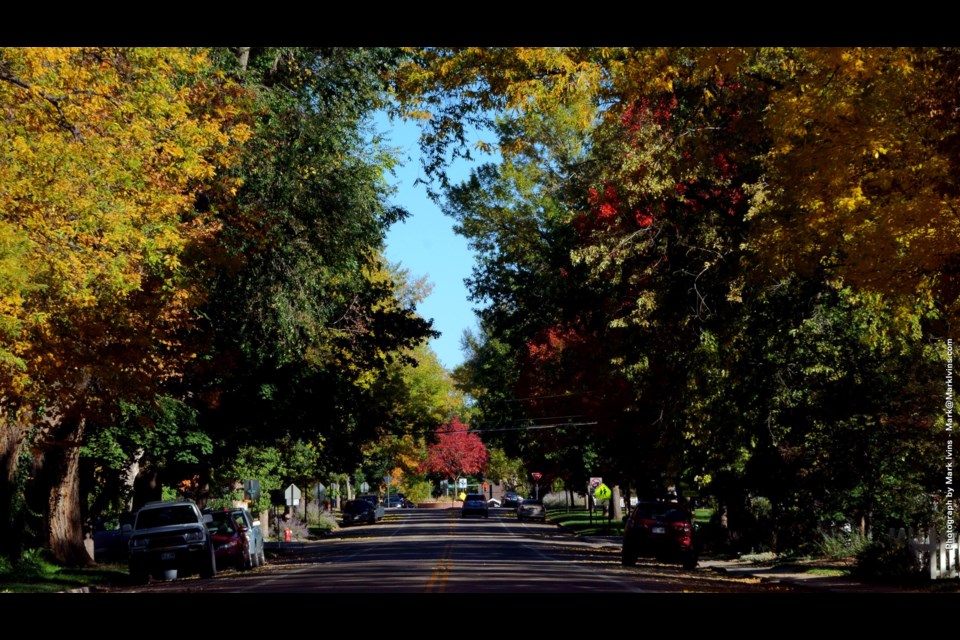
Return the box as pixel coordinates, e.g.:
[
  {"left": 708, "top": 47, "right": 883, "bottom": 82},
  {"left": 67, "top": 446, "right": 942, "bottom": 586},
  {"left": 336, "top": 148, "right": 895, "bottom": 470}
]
[{"left": 127, "top": 500, "right": 217, "bottom": 583}]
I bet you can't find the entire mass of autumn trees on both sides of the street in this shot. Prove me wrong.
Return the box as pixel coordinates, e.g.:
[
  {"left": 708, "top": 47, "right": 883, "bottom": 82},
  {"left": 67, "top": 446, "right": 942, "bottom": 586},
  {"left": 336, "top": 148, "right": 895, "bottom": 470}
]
[{"left": 0, "top": 46, "right": 960, "bottom": 563}]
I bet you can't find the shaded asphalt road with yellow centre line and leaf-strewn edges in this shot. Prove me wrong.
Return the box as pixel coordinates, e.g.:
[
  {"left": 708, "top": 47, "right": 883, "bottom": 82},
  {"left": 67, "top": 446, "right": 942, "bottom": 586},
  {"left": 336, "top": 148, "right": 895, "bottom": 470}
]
[{"left": 101, "top": 509, "right": 792, "bottom": 595}]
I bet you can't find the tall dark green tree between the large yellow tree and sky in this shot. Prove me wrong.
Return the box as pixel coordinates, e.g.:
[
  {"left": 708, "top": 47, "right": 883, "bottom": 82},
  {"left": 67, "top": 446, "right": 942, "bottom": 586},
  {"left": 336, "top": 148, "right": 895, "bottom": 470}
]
[{"left": 176, "top": 48, "right": 432, "bottom": 498}]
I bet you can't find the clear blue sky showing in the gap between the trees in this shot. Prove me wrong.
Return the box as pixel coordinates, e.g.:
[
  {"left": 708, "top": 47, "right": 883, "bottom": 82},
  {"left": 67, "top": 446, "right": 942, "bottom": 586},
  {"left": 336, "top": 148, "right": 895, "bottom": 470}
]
[{"left": 374, "top": 110, "right": 488, "bottom": 370}]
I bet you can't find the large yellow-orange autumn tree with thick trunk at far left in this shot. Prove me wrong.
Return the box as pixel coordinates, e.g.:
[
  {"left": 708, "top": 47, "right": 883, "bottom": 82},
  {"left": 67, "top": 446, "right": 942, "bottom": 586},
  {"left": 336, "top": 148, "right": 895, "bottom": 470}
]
[{"left": 0, "top": 47, "right": 251, "bottom": 563}]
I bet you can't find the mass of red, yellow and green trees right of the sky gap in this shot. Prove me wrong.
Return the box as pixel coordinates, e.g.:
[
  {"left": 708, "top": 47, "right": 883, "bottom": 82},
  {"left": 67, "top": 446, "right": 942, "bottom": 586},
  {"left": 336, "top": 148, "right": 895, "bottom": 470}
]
[{"left": 396, "top": 47, "right": 958, "bottom": 545}]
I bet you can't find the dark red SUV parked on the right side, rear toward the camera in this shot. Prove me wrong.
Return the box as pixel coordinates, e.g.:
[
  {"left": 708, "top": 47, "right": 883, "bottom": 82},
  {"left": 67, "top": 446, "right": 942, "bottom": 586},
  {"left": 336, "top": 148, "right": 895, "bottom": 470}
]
[{"left": 621, "top": 498, "right": 697, "bottom": 569}]
